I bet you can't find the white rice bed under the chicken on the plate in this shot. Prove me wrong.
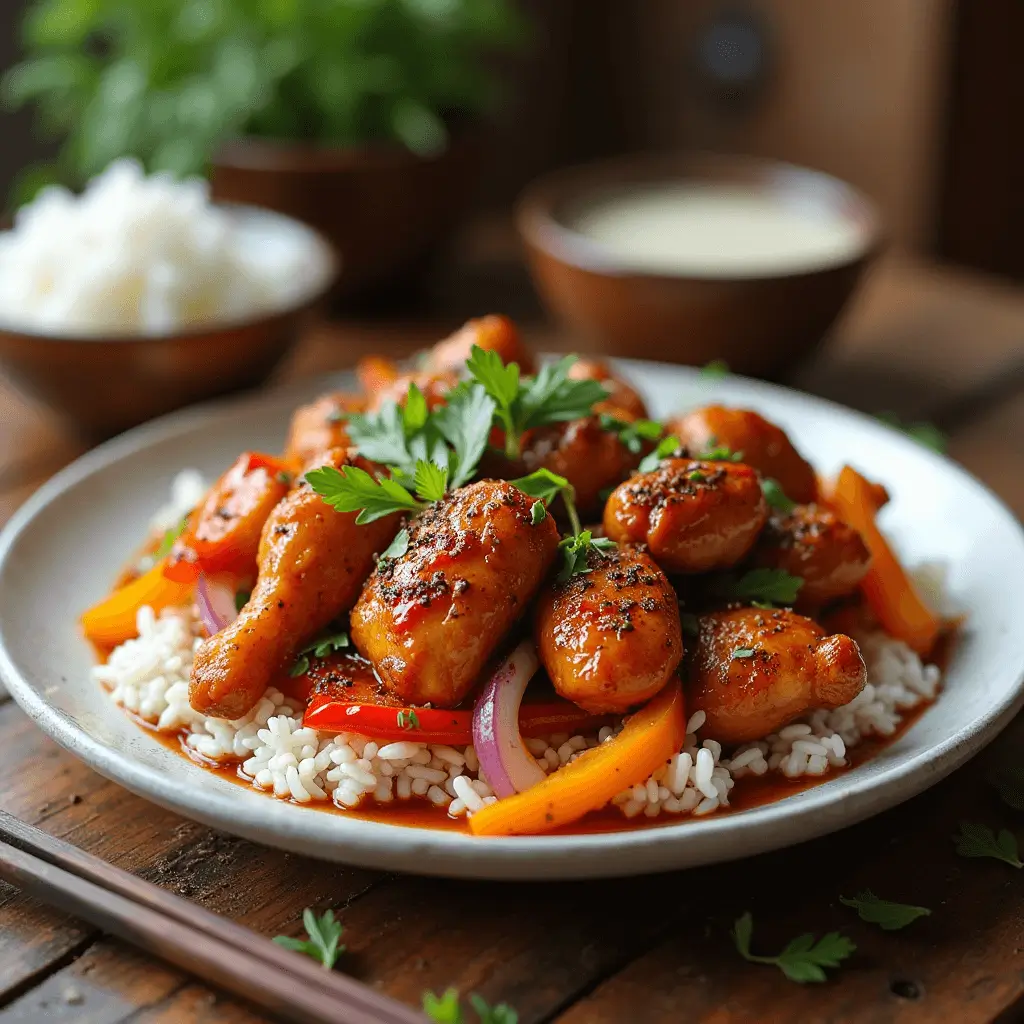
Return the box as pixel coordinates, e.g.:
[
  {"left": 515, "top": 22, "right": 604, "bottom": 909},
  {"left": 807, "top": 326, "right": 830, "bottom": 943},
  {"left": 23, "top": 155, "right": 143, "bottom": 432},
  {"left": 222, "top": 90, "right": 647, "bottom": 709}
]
[{"left": 92, "top": 473, "right": 941, "bottom": 818}]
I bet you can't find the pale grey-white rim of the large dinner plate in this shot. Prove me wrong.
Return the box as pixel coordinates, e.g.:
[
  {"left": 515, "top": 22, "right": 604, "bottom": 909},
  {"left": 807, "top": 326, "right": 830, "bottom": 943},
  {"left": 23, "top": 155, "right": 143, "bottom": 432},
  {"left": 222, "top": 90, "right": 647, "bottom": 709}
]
[{"left": 0, "top": 359, "right": 1024, "bottom": 881}]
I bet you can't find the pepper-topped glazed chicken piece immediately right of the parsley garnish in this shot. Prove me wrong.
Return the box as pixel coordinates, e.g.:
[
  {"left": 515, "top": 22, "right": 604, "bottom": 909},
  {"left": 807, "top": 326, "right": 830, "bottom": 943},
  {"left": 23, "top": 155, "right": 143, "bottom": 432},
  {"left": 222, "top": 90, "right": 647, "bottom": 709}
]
[{"left": 604, "top": 459, "right": 768, "bottom": 572}]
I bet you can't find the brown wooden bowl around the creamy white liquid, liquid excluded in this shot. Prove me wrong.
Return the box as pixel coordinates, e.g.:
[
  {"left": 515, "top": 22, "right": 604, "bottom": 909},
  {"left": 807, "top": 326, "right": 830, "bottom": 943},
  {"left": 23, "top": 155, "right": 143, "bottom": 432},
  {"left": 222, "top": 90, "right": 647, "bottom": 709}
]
[{"left": 516, "top": 154, "right": 882, "bottom": 376}]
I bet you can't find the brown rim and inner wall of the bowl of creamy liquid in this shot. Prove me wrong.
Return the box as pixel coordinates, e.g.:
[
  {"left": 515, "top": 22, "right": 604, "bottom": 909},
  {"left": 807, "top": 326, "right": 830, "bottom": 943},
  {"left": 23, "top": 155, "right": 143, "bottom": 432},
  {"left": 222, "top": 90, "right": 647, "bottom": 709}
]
[{"left": 515, "top": 152, "right": 885, "bottom": 284}]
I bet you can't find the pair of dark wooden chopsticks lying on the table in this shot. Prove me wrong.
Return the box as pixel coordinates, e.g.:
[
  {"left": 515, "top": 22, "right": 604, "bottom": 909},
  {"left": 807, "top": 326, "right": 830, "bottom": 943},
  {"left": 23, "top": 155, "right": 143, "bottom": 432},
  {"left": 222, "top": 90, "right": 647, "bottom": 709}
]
[{"left": 0, "top": 811, "right": 424, "bottom": 1024}]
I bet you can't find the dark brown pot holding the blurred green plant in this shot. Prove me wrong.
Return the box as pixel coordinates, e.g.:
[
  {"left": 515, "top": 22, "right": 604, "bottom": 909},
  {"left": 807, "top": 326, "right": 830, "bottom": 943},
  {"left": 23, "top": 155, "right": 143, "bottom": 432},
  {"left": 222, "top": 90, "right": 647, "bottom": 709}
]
[{"left": 211, "top": 131, "right": 480, "bottom": 298}]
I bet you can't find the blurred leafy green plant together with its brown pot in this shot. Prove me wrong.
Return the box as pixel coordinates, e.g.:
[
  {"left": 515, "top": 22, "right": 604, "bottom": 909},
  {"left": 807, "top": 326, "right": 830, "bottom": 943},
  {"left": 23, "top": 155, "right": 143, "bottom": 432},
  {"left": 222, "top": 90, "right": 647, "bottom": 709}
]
[{"left": 3, "top": 0, "right": 523, "bottom": 295}]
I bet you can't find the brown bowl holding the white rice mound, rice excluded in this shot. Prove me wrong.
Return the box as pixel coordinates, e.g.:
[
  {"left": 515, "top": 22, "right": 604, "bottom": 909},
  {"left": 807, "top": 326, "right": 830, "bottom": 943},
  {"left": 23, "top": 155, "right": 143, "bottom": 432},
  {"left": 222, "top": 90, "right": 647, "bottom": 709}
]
[{"left": 0, "top": 207, "right": 337, "bottom": 440}]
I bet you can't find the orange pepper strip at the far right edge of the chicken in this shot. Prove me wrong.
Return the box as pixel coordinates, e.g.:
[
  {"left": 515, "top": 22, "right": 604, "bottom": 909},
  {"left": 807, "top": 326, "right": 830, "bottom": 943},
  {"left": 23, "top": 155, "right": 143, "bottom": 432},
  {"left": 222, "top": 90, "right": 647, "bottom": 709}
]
[{"left": 830, "top": 466, "right": 943, "bottom": 657}]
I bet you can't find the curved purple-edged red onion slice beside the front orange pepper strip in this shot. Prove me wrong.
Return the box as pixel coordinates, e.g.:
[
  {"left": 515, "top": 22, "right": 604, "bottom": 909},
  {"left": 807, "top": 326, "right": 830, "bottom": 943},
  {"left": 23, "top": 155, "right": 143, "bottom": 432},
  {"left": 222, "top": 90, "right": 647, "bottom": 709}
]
[{"left": 473, "top": 640, "right": 545, "bottom": 799}]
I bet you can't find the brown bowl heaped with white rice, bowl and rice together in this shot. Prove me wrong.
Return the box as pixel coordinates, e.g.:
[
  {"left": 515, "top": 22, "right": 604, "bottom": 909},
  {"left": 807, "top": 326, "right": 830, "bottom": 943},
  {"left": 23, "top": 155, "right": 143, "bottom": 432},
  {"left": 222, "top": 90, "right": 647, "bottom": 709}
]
[{"left": 0, "top": 161, "right": 338, "bottom": 437}]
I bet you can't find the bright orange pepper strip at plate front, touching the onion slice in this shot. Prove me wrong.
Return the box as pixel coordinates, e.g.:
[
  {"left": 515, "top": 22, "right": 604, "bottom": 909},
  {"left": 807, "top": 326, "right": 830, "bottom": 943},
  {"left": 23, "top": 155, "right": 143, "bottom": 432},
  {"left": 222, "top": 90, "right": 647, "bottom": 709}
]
[{"left": 469, "top": 680, "right": 686, "bottom": 836}]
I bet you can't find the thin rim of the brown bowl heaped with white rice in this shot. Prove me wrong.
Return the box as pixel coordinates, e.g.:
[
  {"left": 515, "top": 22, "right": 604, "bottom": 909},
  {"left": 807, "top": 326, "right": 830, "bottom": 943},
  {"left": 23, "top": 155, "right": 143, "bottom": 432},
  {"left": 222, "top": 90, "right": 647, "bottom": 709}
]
[{"left": 0, "top": 203, "right": 341, "bottom": 346}]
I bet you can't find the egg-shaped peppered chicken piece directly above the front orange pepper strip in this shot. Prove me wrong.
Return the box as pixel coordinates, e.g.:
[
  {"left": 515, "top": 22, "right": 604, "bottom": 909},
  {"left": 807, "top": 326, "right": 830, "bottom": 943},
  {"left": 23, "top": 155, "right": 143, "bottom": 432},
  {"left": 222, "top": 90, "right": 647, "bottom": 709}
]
[{"left": 536, "top": 548, "right": 683, "bottom": 714}]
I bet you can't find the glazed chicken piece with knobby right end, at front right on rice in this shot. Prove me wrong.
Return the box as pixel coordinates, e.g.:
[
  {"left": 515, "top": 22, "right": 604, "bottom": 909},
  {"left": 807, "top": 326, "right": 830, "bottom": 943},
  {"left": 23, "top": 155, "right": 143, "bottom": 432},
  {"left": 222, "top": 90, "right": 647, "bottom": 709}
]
[{"left": 687, "top": 608, "right": 867, "bottom": 744}]
